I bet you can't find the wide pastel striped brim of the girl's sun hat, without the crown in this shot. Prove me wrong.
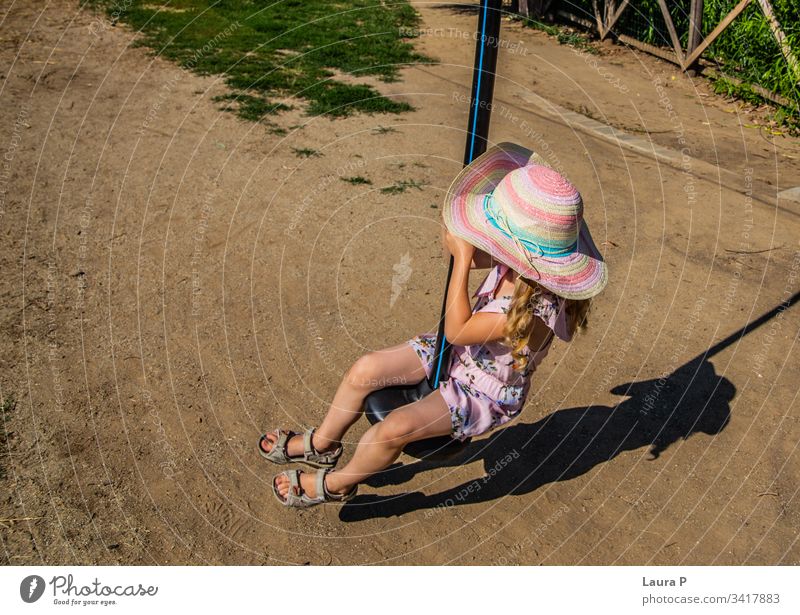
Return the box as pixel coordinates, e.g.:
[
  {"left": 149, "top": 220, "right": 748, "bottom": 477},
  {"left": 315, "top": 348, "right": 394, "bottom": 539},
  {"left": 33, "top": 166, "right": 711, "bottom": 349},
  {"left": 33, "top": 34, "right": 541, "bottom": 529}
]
[{"left": 443, "top": 143, "right": 608, "bottom": 299}]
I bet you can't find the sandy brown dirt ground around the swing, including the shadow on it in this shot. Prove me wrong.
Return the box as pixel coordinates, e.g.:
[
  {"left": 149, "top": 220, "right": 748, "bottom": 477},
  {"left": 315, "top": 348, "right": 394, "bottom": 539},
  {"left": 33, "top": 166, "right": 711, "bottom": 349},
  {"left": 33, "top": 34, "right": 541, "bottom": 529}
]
[{"left": 0, "top": 0, "right": 800, "bottom": 564}]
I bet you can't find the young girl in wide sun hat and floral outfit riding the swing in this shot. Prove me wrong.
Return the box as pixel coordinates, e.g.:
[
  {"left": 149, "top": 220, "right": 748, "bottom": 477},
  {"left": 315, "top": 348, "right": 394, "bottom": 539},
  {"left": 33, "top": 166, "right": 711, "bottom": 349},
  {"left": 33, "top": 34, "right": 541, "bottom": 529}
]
[{"left": 258, "top": 143, "right": 607, "bottom": 507}]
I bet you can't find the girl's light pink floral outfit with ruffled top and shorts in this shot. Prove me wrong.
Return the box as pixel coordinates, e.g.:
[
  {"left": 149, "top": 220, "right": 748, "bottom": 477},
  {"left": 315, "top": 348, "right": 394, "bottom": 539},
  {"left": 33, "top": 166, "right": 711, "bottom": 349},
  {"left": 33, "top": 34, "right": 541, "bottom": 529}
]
[{"left": 408, "top": 265, "right": 570, "bottom": 440}]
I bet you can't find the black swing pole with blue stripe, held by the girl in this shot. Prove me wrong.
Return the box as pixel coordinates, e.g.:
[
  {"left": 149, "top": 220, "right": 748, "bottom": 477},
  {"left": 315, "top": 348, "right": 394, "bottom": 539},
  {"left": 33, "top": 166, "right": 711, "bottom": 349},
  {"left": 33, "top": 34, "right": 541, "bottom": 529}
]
[{"left": 429, "top": 0, "right": 502, "bottom": 389}]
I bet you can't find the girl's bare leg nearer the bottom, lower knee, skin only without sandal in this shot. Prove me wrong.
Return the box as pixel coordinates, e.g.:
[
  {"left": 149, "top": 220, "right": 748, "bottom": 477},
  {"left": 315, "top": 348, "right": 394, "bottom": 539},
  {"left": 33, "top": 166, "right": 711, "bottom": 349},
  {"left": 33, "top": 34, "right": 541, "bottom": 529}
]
[{"left": 275, "top": 391, "right": 452, "bottom": 497}]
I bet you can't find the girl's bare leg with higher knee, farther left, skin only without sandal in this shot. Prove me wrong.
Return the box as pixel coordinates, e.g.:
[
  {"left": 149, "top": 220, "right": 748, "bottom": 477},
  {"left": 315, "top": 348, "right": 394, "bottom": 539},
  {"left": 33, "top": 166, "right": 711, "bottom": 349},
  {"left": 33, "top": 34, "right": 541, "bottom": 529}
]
[{"left": 262, "top": 344, "right": 425, "bottom": 455}]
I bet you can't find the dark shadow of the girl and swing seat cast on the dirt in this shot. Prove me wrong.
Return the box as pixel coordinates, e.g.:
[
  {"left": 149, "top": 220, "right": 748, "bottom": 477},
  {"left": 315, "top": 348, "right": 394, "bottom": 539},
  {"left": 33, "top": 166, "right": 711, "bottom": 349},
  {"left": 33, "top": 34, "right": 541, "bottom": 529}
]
[{"left": 339, "top": 354, "right": 736, "bottom": 521}]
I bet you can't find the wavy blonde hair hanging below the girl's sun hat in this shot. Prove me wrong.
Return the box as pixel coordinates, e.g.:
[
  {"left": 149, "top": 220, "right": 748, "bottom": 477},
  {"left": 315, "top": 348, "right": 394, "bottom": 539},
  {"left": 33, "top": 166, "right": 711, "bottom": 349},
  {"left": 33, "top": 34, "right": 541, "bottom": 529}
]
[{"left": 503, "top": 276, "right": 592, "bottom": 371}]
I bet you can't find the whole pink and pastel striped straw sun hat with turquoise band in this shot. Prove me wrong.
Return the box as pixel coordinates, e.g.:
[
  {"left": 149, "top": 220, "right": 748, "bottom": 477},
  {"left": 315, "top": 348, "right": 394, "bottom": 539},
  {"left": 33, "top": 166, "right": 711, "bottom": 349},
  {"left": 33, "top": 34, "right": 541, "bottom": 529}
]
[{"left": 444, "top": 143, "right": 608, "bottom": 299}]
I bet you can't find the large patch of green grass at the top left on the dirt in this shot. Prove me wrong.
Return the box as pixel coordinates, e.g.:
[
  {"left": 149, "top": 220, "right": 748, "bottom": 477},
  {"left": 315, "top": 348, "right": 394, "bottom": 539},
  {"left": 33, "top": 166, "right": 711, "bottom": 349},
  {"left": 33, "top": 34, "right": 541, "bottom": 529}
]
[{"left": 82, "top": 0, "right": 432, "bottom": 121}]
